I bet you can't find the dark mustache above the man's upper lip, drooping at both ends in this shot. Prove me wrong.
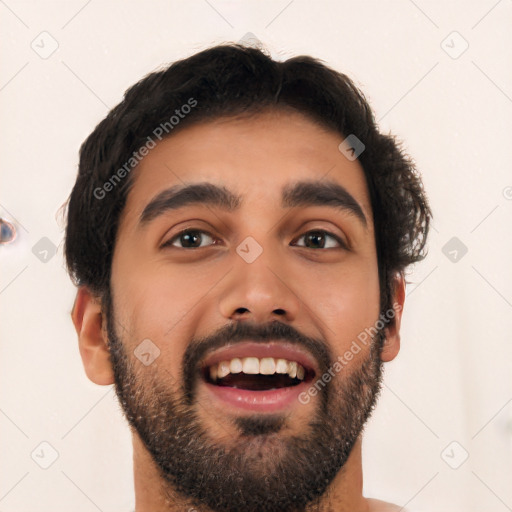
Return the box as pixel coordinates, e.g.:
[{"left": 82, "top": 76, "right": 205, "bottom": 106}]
[{"left": 182, "top": 320, "right": 332, "bottom": 405}]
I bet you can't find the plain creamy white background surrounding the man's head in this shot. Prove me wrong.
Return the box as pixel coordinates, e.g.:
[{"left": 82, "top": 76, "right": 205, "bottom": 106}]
[{"left": 0, "top": 0, "right": 512, "bottom": 512}]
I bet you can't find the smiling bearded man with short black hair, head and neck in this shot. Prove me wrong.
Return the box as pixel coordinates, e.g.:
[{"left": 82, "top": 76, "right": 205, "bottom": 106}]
[{"left": 65, "top": 45, "right": 431, "bottom": 512}]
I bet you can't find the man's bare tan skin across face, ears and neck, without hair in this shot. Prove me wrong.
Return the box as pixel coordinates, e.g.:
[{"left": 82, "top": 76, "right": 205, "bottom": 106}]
[{"left": 72, "top": 112, "right": 405, "bottom": 512}]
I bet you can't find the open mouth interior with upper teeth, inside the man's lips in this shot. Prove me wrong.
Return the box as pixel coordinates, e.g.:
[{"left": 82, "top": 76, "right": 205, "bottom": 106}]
[{"left": 203, "top": 357, "right": 314, "bottom": 391}]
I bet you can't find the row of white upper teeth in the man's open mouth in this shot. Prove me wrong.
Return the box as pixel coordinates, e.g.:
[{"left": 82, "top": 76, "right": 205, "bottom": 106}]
[{"left": 210, "top": 357, "right": 306, "bottom": 381}]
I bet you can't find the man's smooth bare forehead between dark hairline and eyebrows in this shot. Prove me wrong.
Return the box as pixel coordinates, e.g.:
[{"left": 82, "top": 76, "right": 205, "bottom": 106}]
[{"left": 121, "top": 112, "right": 372, "bottom": 232}]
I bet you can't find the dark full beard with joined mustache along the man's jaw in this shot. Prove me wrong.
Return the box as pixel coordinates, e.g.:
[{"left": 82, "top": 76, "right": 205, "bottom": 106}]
[{"left": 106, "top": 297, "right": 385, "bottom": 512}]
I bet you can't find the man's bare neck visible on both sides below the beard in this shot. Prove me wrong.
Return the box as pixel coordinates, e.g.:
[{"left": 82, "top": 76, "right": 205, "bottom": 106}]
[{"left": 132, "top": 431, "right": 370, "bottom": 512}]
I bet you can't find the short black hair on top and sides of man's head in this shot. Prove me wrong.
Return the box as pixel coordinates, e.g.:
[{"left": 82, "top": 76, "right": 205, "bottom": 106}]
[{"left": 65, "top": 44, "right": 432, "bottom": 316}]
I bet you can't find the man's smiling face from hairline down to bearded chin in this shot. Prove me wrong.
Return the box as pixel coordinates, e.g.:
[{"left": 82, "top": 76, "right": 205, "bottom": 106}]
[{"left": 109, "top": 113, "right": 384, "bottom": 511}]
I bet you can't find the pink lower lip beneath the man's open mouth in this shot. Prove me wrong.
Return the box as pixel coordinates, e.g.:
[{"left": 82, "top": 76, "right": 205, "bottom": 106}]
[{"left": 202, "top": 381, "right": 308, "bottom": 412}]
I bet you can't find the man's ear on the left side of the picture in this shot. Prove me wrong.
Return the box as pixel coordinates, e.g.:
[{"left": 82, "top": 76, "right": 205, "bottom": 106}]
[{"left": 71, "top": 286, "right": 114, "bottom": 386}]
